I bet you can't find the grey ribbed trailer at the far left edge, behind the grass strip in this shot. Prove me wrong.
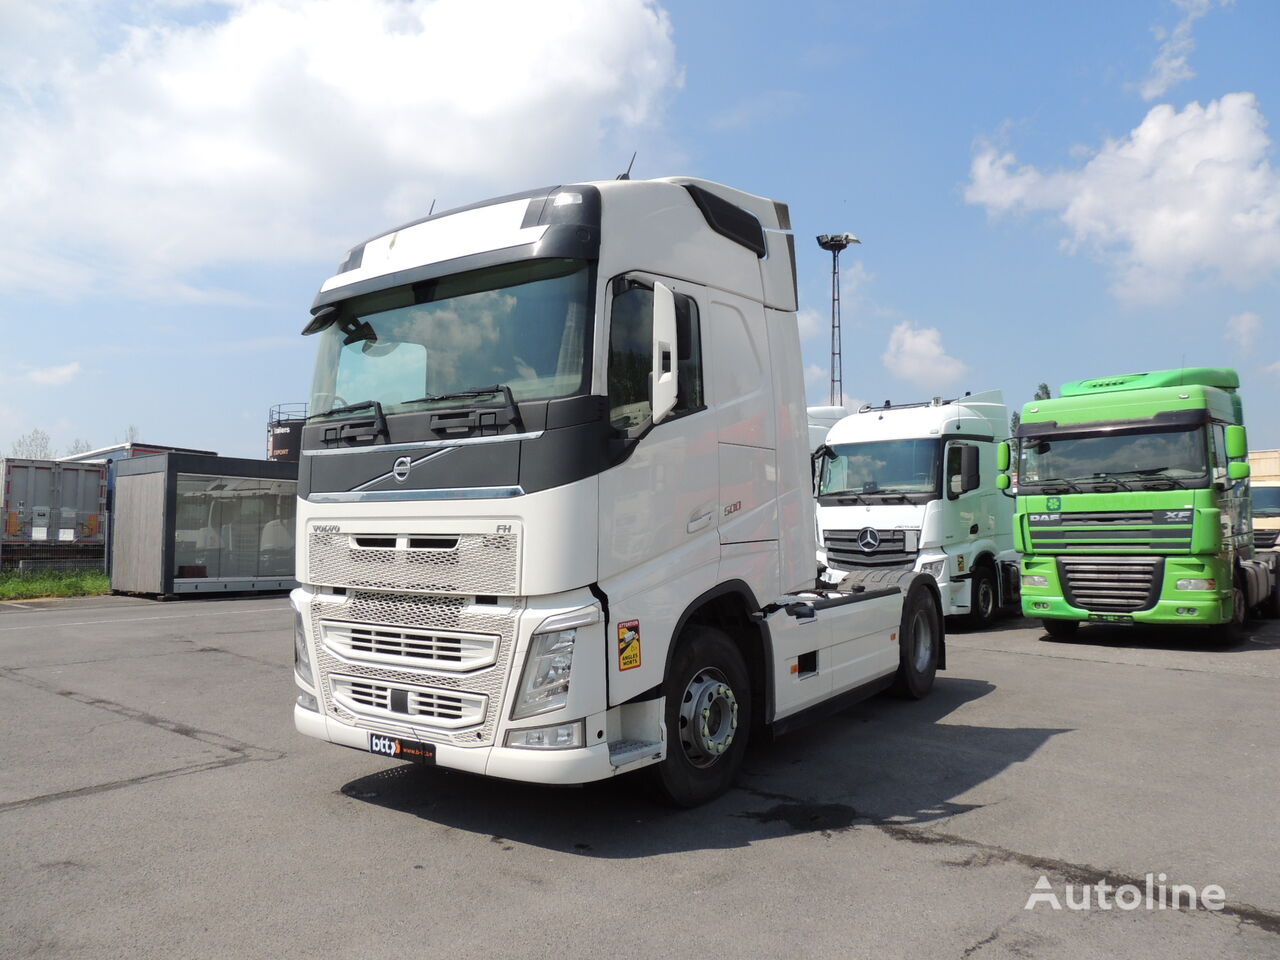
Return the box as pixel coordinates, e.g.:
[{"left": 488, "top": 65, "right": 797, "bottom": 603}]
[{"left": 0, "top": 457, "right": 106, "bottom": 568}]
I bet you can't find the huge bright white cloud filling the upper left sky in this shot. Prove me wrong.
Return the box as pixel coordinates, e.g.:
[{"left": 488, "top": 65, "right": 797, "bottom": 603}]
[{"left": 0, "top": 0, "right": 682, "bottom": 298}]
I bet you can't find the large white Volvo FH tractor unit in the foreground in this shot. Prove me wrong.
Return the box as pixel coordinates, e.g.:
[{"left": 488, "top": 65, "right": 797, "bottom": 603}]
[{"left": 292, "top": 178, "right": 945, "bottom": 805}]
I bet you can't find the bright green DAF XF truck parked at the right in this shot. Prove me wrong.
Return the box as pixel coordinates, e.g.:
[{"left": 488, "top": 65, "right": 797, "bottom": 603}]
[{"left": 997, "top": 367, "right": 1280, "bottom": 640}]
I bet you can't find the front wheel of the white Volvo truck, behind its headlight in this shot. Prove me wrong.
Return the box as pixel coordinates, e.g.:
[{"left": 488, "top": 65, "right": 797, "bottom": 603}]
[{"left": 648, "top": 626, "right": 751, "bottom": 806}]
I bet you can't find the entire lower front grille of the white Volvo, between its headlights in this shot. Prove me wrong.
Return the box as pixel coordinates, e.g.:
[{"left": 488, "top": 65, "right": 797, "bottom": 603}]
[{"left": 310, "top": 590, "right": 522, "bottom": 746}]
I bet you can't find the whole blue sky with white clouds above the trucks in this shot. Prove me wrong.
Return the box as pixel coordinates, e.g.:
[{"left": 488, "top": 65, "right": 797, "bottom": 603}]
[{"left": 0, "top": 0, "right": 1280, "bottom": 456}]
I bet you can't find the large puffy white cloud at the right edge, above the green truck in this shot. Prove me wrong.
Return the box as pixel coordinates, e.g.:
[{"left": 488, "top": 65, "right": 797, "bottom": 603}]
[{"left": 965, "top": 93, "right": 1280, "bottom": 300}]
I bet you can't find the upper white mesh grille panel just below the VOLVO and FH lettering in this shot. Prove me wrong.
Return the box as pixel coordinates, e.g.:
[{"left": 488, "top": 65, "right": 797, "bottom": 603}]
[{"left": 307, "top": 530, "right": 520, "bottom": 596}]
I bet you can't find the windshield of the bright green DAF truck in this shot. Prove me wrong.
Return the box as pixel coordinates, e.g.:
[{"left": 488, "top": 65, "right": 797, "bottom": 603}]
[{"left": 1018, "top": 426, "right": 1208, "bottom": 488}]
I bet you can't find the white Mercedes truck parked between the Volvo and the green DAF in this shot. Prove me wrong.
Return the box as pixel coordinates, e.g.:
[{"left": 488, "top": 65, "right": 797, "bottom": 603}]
[{"left": 815, "top": 390, "right": 1018, "bottom": 627}]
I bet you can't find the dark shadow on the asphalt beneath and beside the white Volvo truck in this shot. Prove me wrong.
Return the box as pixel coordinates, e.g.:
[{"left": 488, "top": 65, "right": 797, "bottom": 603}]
[{"left": 342, "top": 678, "right": 1069, "bottom": 859}]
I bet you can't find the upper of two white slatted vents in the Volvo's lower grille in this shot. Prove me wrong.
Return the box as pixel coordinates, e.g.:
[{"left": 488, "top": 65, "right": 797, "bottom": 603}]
[{"left": 321, "top": 621, "right": 499, "bottom": 672}]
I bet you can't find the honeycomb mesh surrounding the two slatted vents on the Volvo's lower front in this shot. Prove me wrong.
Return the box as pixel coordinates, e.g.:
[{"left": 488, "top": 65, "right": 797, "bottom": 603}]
[{"left": 310, "top": 591, "right": 520, "bottom": 746}]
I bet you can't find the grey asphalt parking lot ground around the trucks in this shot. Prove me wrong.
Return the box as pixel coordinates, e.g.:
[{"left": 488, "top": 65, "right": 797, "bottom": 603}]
[{"left": 0, "top": 596, "right": 1280, "bottom": 960}]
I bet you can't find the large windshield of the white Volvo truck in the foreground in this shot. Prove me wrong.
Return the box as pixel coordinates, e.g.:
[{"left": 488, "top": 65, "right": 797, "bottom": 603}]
[{"left": 311, "top": 260, "right": 590, "bottom": 416}]
